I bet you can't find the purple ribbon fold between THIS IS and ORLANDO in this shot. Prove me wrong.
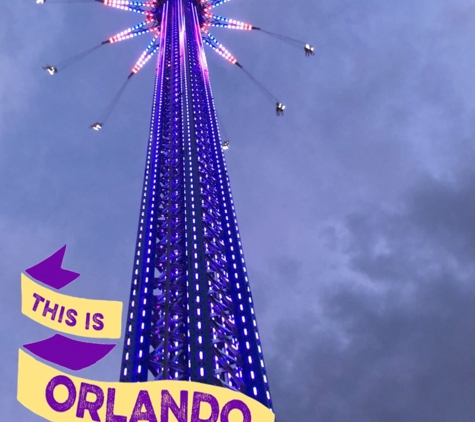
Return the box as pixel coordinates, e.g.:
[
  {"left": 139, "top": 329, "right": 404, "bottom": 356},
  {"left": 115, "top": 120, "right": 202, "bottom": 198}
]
[{"left": 23, "top": 334, "right": 115, "bottom": 371}]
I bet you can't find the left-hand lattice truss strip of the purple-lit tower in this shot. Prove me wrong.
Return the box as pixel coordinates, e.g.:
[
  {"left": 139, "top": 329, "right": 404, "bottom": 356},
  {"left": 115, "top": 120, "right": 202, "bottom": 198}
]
[{"left": 150, "top": 1, "right": 189, "bottom": 380}]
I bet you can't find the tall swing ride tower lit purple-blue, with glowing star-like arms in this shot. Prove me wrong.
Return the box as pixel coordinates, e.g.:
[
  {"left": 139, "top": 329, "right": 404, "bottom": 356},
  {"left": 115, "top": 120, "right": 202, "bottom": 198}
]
[{"left": 110, "top": 0, "right": 271, "bottom": 408}]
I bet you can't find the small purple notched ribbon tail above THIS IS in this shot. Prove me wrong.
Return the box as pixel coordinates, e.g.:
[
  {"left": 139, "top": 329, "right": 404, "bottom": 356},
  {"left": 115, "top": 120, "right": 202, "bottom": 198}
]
[{"left": 25, "top": 245, "right": 81, "bottom": 290}]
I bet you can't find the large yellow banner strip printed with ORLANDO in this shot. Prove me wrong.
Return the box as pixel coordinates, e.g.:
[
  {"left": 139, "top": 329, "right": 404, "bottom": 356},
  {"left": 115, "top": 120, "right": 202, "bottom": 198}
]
[{"left": 17, "top": 350, "right": 274, "bottom": 422}]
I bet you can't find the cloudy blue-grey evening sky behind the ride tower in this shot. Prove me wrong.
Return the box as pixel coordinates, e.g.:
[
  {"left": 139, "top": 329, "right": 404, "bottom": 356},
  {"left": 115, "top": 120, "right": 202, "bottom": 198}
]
[{"left": 0, "top": 0, "right": 475, "bottom": 422}]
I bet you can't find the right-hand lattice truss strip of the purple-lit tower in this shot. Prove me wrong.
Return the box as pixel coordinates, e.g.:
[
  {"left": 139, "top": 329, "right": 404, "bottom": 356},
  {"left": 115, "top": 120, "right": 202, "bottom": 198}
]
[{"left": 186, "top": 0, "right": 245, "bottom": 391}]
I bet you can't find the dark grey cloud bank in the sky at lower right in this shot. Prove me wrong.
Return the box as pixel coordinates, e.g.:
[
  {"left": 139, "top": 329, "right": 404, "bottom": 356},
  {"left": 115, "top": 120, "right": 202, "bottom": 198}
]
[{"left": 268, "top": 171, "right": 475, "bottom": 422}]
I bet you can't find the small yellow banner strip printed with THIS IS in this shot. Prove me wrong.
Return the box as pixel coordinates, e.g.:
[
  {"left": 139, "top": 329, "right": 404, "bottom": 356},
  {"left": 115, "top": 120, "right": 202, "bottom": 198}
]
[{"left": 21, "top": 274, "right": 122, "bottom": 339}]
